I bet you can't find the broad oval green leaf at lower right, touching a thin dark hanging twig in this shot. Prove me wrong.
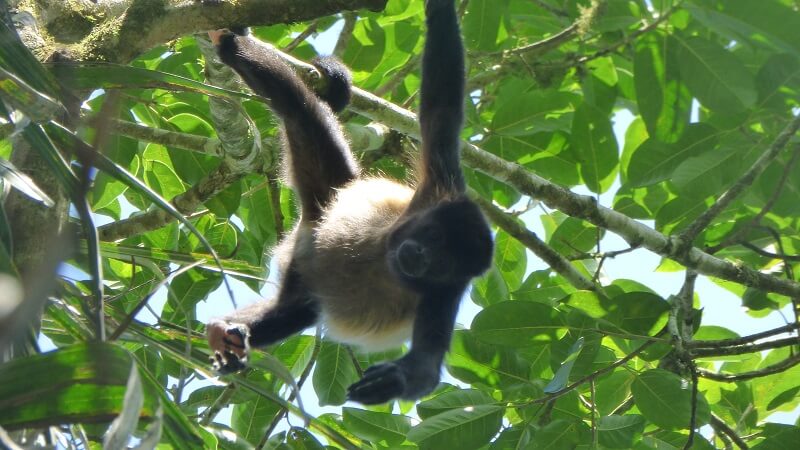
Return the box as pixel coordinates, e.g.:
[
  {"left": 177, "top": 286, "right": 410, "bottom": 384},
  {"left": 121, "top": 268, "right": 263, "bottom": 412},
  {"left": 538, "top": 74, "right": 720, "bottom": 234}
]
[{"left": 631, "top": 369, "right": 709, "bottom": 430}]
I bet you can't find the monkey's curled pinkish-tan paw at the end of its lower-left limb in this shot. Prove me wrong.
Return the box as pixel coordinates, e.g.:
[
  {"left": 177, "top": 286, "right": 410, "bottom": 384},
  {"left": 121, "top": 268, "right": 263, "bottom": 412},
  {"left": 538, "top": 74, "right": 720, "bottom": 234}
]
[{"left": 206, "top": 320, "right": 248, "bottom": 375}]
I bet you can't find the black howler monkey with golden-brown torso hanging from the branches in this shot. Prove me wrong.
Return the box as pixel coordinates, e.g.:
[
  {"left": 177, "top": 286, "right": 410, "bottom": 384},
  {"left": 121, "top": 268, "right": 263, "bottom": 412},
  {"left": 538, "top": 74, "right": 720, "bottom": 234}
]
[{"left": 208, "top": 0, "right": 493, "bottom": 404}]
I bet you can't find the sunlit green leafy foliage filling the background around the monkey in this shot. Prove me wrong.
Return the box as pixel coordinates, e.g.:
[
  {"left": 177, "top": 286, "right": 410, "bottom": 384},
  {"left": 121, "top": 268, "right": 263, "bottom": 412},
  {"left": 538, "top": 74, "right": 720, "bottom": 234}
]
[{"left": 0, "top": 0, "right": 800, "bottom": 450}]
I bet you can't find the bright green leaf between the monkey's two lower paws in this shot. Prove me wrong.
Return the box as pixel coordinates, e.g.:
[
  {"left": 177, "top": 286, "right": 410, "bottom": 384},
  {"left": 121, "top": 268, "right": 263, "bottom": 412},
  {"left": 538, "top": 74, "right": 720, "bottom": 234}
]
[{"left": 313, "top": 341, "right": 358, "bottom": 406}]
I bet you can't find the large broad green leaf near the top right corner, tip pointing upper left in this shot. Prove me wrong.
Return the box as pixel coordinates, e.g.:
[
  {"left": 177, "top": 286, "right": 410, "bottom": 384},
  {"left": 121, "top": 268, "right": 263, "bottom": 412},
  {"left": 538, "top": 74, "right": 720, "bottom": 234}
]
[{"left": 676, "top": 35, "right": 757, "bottom": 112}]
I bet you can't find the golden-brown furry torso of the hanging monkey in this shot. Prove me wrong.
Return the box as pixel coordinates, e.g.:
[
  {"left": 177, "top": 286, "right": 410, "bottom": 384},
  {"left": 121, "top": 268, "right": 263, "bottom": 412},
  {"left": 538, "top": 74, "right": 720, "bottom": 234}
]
[{"left": 294, "top": 178, "right": 419, "bottom": 350}]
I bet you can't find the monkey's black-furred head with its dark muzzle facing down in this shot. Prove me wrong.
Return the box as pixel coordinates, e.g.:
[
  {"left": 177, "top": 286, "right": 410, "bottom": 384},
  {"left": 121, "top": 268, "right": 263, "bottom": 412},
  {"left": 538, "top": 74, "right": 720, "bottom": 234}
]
[{"left": 387, "top": 197, "right": 493, "bottom": 290}]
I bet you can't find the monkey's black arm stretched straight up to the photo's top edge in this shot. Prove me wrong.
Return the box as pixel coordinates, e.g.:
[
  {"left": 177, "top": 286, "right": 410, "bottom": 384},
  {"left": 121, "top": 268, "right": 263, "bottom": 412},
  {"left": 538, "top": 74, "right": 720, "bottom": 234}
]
[{"left": 415, "top": 0, "right": 465, "bottom": 199}]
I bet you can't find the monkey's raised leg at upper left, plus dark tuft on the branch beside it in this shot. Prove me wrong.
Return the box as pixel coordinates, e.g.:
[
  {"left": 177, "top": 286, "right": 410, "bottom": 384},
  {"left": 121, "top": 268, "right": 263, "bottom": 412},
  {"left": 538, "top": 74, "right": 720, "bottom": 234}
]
[{"left": 209, "top": 32, "right": 358, "bottom": 220}]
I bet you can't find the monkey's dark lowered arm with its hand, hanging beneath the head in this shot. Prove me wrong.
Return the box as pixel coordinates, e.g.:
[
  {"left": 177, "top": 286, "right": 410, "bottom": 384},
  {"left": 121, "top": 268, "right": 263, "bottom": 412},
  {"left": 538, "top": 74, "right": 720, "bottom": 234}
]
[{"left": 348, "top": 288, "right": 463, "bottom": 405}]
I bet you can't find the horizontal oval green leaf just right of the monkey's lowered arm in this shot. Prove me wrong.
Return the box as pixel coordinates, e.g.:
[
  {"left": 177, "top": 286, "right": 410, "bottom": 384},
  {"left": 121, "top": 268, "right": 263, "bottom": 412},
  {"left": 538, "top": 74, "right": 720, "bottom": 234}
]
[{"left": 471, "top": 301, "right": 566, "bottom": 347}]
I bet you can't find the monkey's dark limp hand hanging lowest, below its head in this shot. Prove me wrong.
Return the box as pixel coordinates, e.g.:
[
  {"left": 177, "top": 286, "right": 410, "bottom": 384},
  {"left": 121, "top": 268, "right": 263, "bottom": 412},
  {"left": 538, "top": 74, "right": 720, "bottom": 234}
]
[{"left": 347, "top": 353, "right": 439, "bottom": 405}]
